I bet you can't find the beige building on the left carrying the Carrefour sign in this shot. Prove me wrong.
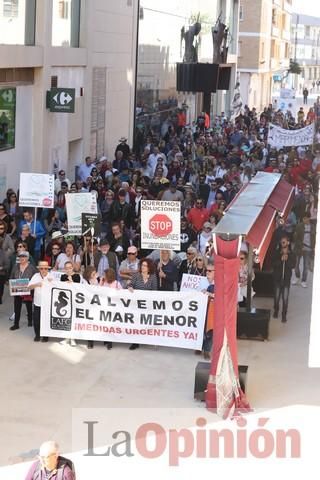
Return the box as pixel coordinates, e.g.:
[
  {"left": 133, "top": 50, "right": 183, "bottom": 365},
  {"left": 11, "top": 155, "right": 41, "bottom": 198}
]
[{"left": 0, "top": 0, "right": 138, "bottom": 198}]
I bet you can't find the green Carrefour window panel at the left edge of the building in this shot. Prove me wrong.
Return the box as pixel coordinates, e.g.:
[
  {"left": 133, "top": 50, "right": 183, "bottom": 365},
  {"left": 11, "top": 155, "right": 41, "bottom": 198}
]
[{"left": 0, "top": 88, "right": 16, "bottom": 151}]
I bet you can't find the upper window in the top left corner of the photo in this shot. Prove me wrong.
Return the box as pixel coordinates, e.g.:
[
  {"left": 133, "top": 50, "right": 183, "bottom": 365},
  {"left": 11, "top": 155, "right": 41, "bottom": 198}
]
[{"left": 0, "top": 0, "right": 36, "bottom": 45}]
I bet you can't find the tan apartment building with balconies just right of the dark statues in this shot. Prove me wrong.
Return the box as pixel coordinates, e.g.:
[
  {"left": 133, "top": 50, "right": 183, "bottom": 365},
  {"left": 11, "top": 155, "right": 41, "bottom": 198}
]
[{"left": 238, "top": 0, "right": 292, "bottom": 110}]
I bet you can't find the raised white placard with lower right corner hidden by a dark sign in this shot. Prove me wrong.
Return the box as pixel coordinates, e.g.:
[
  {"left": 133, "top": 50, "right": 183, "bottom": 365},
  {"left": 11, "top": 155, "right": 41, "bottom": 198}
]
[{"left": 66, "top": 192, "right": 98, "bottom": 235}]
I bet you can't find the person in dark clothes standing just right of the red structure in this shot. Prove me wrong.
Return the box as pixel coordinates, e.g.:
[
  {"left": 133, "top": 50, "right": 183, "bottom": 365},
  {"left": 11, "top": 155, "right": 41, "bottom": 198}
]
[{"left": 272, "top": 235, "right": 295, "bottom": 323}]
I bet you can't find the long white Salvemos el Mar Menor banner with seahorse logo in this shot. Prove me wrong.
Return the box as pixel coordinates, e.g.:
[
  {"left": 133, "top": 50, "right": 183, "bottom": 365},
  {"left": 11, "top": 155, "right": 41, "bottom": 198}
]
[{"left": 41, "top": 282, "right": 207, "bottom": 350}]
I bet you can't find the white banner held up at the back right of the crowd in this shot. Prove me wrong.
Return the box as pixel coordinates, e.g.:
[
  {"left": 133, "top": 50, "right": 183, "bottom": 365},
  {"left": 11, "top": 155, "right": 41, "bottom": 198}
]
[{"left": 268, "top": 123, "right": 314, "bottom": 149}]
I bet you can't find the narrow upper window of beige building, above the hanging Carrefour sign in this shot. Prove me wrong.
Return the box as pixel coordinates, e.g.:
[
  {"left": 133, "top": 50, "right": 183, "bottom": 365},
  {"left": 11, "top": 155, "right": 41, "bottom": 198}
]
[{"left": 52, "top": 0, "right": 81, "bottom": 47}]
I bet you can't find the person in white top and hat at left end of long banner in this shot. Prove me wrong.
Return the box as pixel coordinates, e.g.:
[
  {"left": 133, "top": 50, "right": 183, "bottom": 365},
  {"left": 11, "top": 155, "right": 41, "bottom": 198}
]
[{"left": 29, "top": 260, "right": 53, "bottom": 342}]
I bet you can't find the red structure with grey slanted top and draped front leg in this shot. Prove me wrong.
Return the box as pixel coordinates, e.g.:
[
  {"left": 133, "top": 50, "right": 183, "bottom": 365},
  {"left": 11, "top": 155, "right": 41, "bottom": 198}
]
[{"left": 206, "top": 172, "right": 294, "bottom": 418}]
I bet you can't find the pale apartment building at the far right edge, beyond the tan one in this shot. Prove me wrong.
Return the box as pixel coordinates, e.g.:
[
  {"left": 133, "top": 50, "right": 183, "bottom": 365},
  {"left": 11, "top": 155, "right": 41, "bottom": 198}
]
[{"left": 291, "top": 13, "right": 320, "bottom": 92}]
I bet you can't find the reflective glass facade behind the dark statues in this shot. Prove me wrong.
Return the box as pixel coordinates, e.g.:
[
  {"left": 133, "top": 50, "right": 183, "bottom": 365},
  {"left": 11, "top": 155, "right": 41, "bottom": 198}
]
[{"left": 135, "top": 0, "right": 234, "bottom": 142}]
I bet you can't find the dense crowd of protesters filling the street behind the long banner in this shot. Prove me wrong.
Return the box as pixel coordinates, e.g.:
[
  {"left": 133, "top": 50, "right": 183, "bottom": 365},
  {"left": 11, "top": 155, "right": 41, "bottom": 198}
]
[{"left": 0, "top": 102, "right": 320, "bottom": 351}]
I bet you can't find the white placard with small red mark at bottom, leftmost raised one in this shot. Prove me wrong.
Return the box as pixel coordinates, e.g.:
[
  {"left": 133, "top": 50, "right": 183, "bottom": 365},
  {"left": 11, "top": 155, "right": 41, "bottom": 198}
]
[{"left": 19, "top": 173, "right": 54, "bottom": 208}]
